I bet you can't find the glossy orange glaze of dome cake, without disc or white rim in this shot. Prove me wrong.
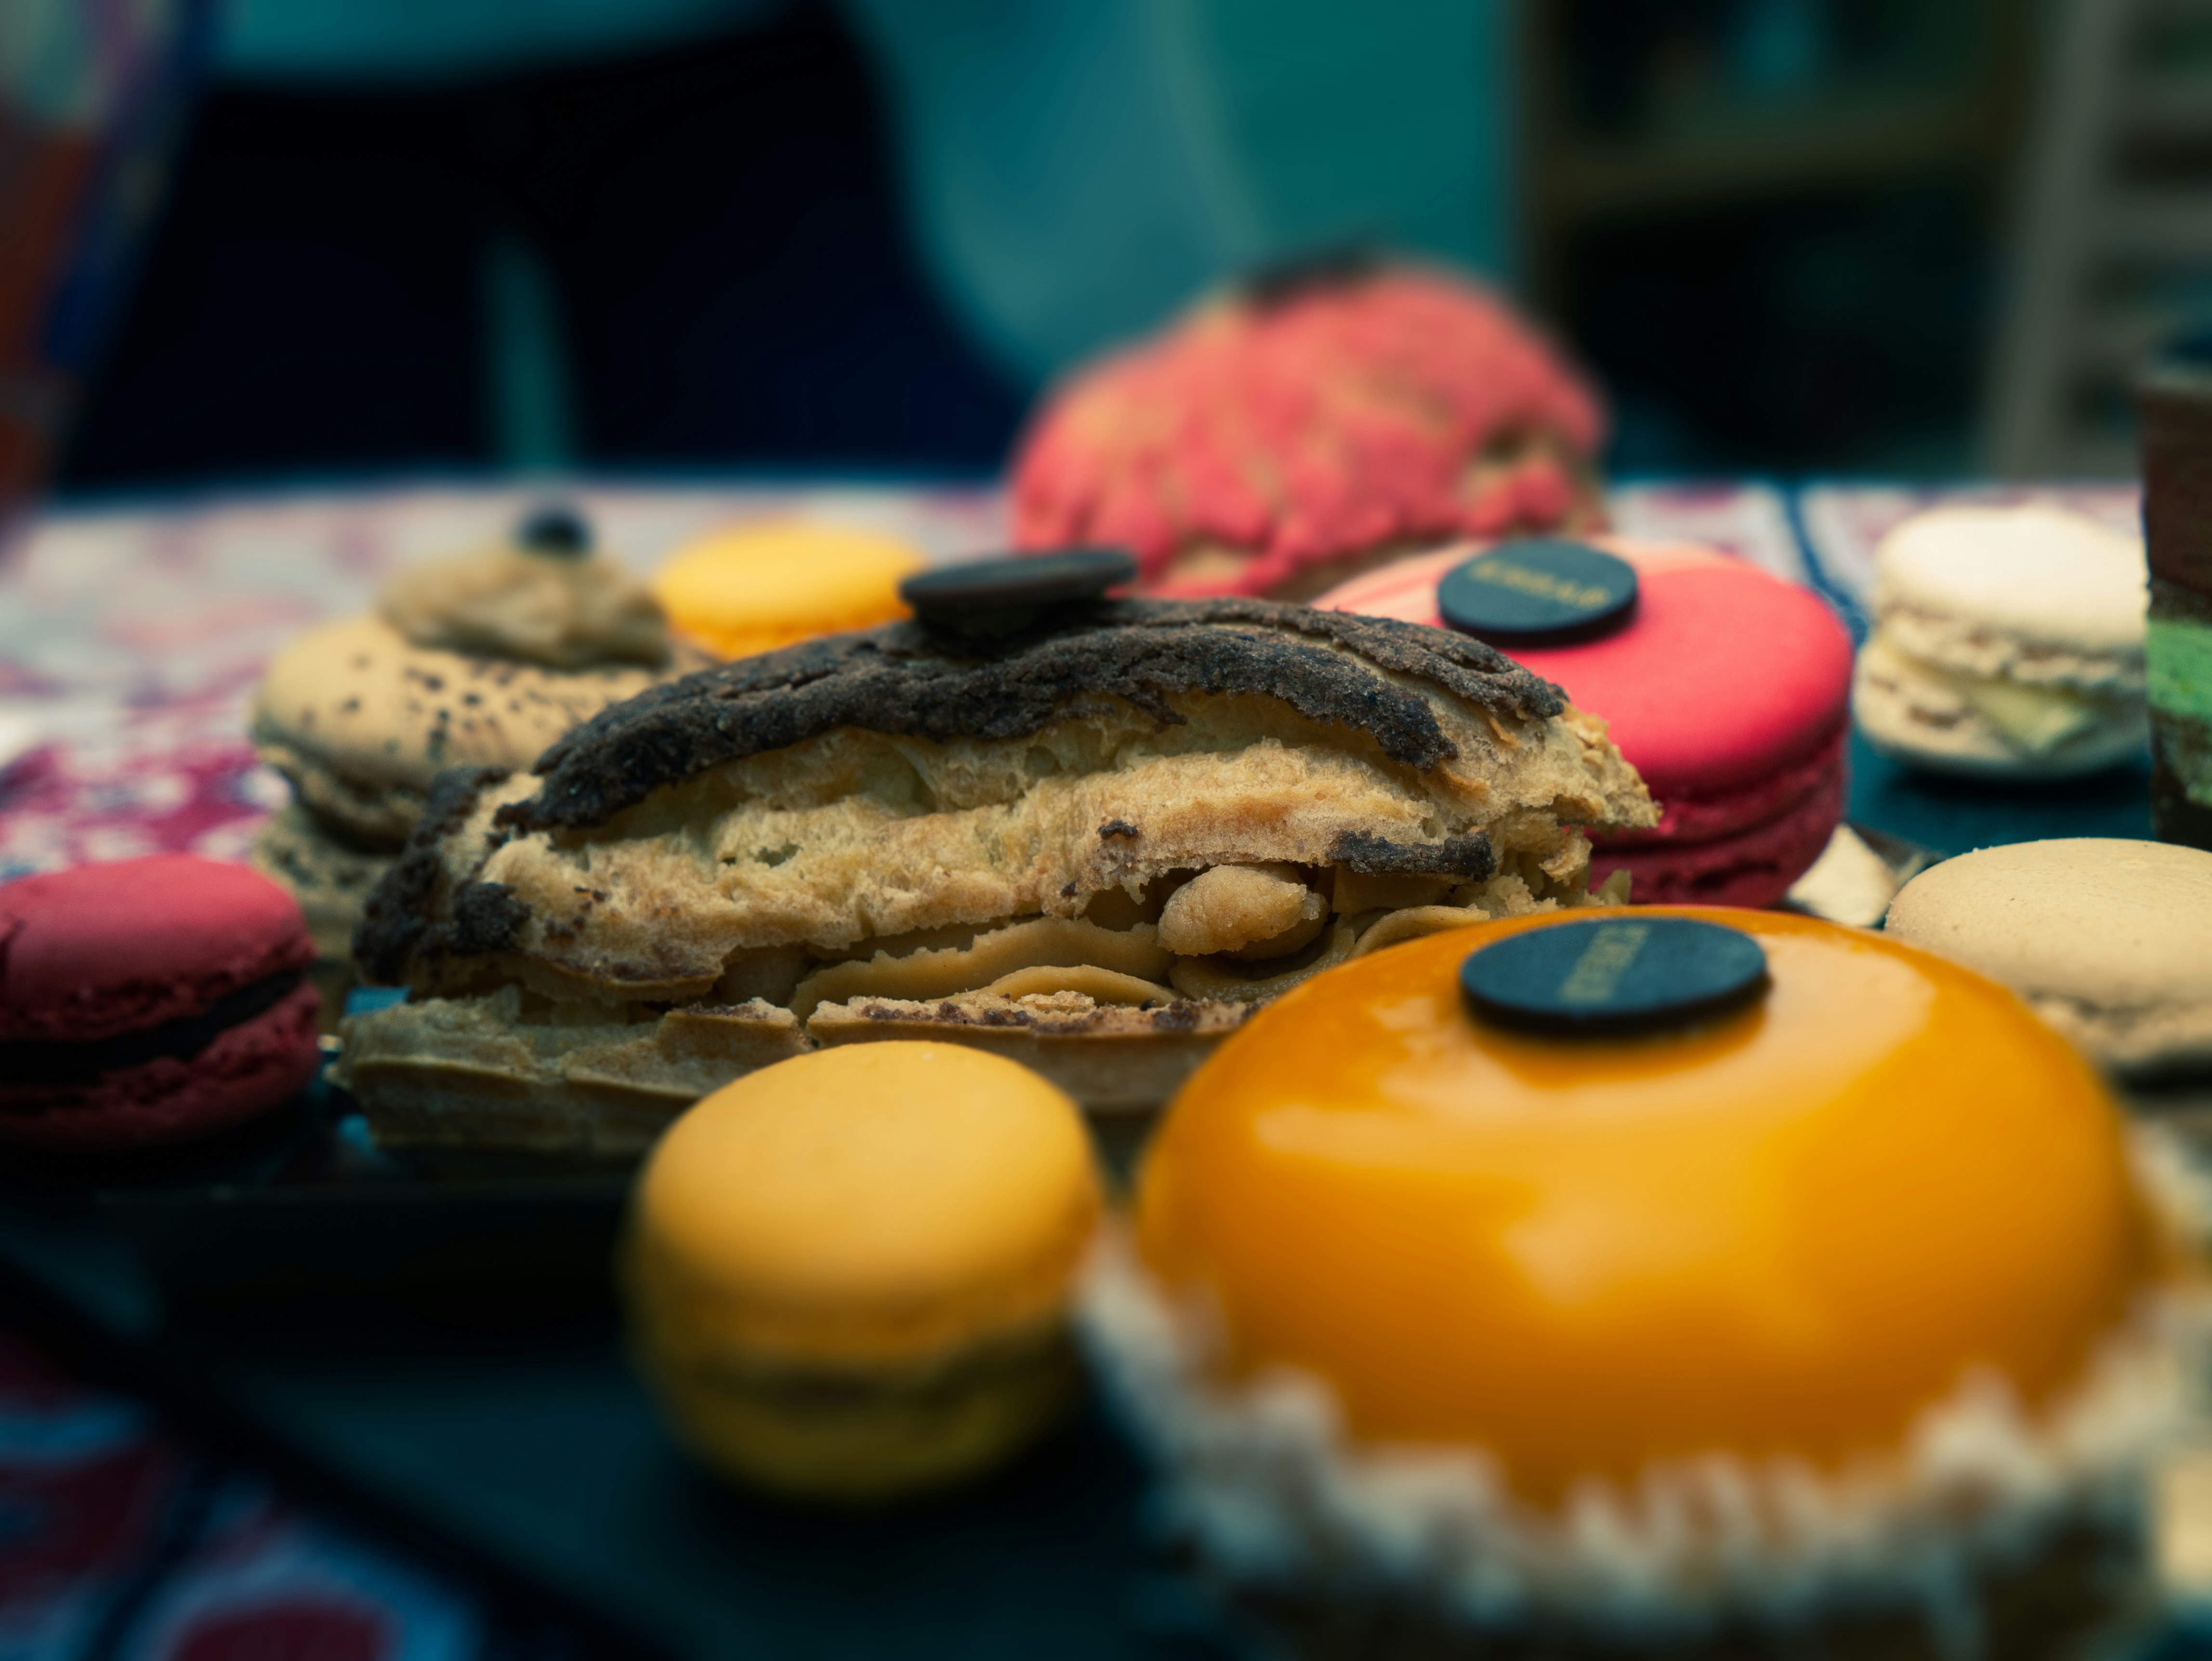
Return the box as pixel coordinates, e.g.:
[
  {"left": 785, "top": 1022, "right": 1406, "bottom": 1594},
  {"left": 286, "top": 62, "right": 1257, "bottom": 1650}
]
[{"left": 1137, "top": 907, "right": 2163, "bottom": 1502}]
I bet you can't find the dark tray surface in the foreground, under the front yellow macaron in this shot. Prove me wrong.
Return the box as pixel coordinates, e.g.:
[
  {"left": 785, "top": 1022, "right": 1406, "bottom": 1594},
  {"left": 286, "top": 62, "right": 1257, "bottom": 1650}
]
[{"left": 0, "top": 1197, "right": 1263, "bottom": 1661}]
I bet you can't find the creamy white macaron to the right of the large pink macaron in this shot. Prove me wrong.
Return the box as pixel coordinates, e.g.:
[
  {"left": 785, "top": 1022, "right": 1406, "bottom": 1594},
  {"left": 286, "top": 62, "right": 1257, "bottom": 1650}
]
[{"left": 1852, "top": 504, "right": 2148, "bottom": 778}]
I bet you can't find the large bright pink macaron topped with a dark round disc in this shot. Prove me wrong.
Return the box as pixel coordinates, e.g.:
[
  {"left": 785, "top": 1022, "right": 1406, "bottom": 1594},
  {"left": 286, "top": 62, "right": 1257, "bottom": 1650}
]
[{"left": 1314, "top": 538, "right": 1852, "bottom": 905}]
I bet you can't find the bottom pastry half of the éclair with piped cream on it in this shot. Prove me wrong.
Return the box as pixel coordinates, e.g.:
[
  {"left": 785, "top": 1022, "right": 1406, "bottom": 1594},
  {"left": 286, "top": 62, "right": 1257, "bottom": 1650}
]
[{"left": 334, "top": 858, "right": 1619, "bottom": 1159}]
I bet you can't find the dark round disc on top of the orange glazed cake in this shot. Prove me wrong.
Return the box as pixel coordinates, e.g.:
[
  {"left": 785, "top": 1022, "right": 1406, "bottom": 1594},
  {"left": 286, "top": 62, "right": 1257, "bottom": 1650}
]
[{"left": 1460, "top": 911, "right": 1767, "bottom": 1037}]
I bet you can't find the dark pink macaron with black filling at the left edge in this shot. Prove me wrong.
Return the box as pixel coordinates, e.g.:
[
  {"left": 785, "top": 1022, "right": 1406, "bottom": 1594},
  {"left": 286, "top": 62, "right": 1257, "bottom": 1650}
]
[{"left": 0, "top": 854, "right": 321, "bottom": 1150}]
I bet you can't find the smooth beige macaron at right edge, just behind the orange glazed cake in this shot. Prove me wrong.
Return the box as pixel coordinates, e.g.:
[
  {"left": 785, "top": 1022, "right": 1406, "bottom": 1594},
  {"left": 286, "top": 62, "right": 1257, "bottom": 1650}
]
[{"left": 1887, "top": 836, "right": 2212, "bottom": 1077}]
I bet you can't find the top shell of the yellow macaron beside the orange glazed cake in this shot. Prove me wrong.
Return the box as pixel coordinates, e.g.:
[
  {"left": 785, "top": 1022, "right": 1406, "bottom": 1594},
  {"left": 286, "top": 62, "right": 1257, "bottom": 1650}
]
[{"left": 631, "top": 1041, "right": 1102, "bottom": 1367}]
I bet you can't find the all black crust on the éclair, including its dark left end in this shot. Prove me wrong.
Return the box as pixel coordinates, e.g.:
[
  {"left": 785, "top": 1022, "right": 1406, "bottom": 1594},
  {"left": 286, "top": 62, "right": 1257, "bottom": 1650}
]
[{"left": 354, "top": 599, "right": 1566, "bottom": 984}]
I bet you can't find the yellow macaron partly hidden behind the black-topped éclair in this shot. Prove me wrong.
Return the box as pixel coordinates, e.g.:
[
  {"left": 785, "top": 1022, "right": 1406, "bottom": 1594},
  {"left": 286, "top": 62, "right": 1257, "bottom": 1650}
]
[{"left": 653, "top": 520, "right": 927, "bottom": 657}]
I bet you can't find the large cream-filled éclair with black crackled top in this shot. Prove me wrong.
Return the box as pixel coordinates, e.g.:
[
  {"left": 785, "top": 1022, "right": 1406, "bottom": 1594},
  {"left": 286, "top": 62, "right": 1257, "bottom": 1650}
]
[{"left": 341, "top": 599, "right": 1657, "bottom": 1155}]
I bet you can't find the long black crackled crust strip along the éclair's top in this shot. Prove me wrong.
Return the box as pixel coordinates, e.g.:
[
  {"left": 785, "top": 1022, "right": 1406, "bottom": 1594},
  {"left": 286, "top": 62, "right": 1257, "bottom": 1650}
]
[{"left": 498, "top": 599, "right": 1566, "bottom": 831}]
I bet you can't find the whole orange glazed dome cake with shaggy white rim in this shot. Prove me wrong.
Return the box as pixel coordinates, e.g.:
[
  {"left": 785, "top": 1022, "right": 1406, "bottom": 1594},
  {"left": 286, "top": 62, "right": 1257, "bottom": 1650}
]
[{"left": 1088, "top": 909, "right": 2199, "bottom": 1654}]
